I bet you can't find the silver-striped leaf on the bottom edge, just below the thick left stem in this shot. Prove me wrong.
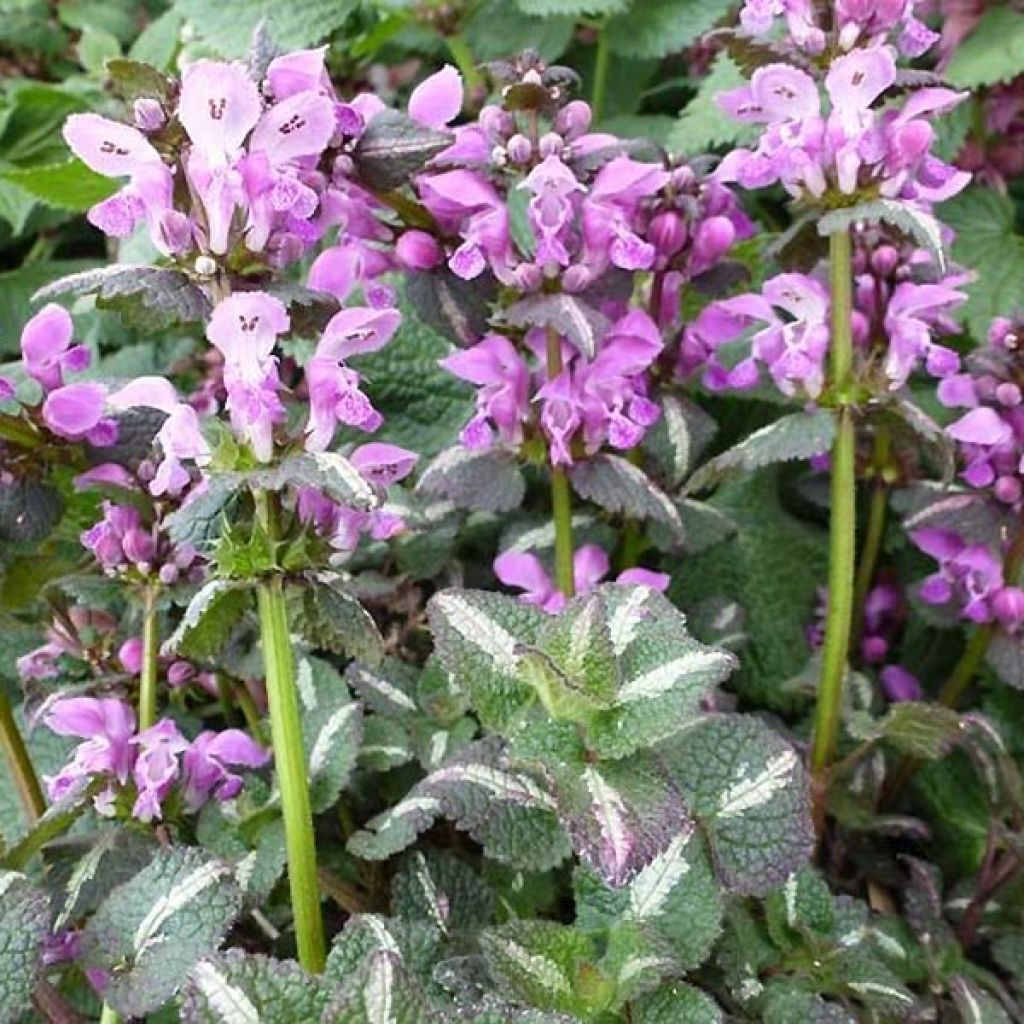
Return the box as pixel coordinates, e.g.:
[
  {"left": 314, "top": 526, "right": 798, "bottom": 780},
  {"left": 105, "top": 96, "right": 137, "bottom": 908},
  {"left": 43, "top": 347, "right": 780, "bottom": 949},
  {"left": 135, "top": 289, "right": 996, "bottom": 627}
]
[{"left": 181, "top": 949, "right": 332, "bottom": 1024}]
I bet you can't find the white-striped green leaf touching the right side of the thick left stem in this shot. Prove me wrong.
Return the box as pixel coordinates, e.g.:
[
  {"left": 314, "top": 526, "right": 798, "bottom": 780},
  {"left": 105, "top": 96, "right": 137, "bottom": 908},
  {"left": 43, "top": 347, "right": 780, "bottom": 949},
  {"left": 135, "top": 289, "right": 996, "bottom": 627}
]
[{"left": 298, "top": 657, "right": 362, "bottom": 813}]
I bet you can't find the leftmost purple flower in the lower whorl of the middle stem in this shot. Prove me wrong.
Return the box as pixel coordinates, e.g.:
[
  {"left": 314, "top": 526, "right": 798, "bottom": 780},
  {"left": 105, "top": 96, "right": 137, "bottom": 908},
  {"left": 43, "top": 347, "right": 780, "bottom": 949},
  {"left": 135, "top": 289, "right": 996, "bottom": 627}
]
[{"left": 440, "top": 334, "right": 529, "bottom": 447}]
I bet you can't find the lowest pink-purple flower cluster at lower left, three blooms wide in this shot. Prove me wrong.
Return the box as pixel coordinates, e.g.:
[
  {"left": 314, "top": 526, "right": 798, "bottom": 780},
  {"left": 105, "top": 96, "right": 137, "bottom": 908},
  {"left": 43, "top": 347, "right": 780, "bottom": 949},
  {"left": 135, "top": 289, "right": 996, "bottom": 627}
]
[{"left": 43, "top": 697, "right": 269, "bottom": 821}]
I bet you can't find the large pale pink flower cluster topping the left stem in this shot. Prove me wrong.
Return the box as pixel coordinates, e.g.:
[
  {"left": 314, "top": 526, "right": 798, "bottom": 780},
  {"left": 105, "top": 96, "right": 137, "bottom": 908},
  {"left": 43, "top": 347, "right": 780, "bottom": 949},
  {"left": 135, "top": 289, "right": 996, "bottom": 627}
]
[{"left": 65, "top": 49, "right": 461, "bottom": 273}]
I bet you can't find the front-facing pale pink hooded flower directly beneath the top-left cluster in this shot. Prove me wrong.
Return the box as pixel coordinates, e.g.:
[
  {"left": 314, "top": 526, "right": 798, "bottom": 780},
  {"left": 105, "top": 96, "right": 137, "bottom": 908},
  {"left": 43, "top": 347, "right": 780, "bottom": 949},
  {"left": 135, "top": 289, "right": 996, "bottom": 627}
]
[{"left": 206, "top": 292, "right": 291, "bottom": 462}]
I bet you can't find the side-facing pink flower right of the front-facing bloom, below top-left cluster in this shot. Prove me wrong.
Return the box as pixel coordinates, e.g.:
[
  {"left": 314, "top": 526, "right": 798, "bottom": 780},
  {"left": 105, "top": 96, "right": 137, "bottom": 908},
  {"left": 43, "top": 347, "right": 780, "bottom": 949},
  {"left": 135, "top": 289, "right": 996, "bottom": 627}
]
[{"left": 306, "top": 308, "right": 401, "bottom": 452}]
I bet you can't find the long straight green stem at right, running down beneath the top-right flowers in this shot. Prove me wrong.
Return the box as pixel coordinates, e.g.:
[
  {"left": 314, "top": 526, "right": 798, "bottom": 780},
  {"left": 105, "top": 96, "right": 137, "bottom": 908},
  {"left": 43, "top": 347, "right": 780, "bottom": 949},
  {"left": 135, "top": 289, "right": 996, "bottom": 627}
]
[{"left": 811, "top": 230, "right": 857, "bottom": 778}]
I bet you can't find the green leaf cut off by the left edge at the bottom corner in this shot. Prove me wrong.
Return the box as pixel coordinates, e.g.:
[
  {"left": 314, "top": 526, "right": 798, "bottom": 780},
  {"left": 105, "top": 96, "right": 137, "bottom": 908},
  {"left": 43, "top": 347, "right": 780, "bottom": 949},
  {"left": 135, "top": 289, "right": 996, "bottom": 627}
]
[{"left": 0, "top": 871, "right": 49, "bottom": 1024}]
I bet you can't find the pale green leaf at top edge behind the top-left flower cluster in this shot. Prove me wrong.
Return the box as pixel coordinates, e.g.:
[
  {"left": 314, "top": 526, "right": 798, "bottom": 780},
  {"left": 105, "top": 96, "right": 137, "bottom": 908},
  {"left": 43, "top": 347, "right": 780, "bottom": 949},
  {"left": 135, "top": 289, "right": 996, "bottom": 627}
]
[{"left": 174, "top": 0, "right": 358, "bottom": 57}]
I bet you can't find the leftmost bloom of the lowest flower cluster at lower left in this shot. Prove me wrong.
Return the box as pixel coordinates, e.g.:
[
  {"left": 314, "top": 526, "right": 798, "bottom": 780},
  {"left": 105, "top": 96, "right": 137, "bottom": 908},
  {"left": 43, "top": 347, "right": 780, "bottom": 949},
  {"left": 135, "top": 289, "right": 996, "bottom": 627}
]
[{"left": 43, "top": 697, "right": 135, "bottom": 806}]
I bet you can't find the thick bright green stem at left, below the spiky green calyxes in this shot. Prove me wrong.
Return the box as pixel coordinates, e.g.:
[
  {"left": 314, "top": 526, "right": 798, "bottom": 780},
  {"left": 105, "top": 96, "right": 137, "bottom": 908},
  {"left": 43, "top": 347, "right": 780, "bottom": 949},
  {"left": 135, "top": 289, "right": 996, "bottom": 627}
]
[{"left": 256, "top": 577, "right": 326, "bottom": 974}]
